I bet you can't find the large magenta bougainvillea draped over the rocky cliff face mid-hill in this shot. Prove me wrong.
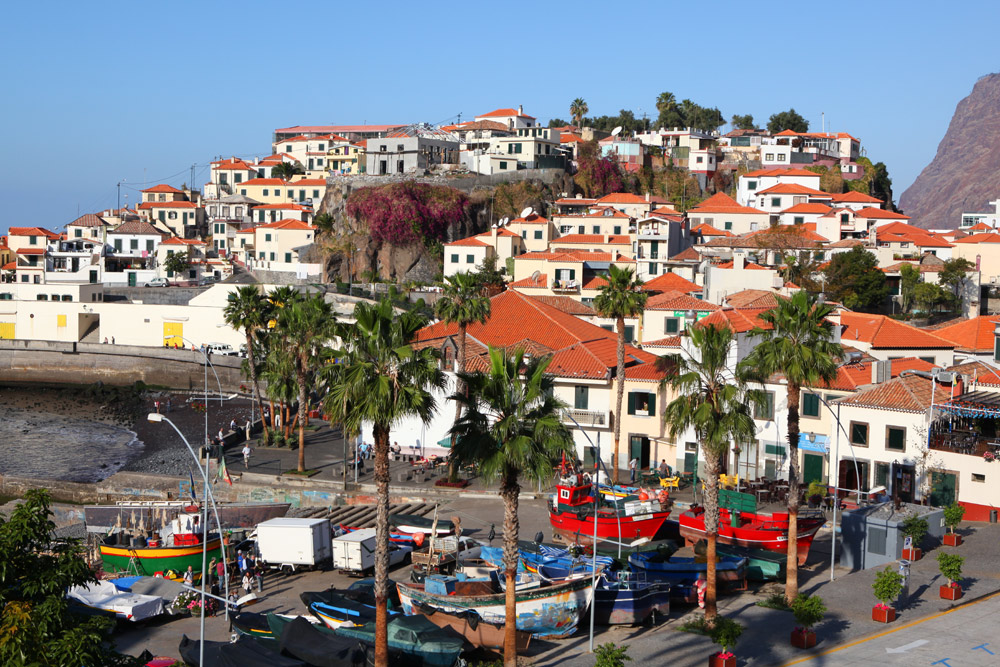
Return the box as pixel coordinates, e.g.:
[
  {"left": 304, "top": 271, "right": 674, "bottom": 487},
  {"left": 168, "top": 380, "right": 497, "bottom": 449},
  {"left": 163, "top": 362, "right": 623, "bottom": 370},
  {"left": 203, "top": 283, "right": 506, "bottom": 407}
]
[{"left": 347, "top": 181, "right": 469, "bottom": 246}]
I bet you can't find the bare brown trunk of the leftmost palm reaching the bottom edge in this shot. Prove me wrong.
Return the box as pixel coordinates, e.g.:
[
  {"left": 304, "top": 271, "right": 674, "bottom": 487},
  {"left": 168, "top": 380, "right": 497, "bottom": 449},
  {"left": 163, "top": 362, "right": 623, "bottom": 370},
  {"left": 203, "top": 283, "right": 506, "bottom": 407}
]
[{"left": 372, "top": 423, "right": 392, "bottom": 667}]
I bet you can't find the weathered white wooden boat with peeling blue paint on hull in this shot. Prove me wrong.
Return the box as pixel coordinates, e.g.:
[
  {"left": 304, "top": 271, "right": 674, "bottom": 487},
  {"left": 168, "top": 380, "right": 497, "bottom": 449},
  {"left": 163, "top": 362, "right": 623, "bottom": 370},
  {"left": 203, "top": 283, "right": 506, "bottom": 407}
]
[{"left": 396, "top": 572, "right": 594, "bottom": 639}]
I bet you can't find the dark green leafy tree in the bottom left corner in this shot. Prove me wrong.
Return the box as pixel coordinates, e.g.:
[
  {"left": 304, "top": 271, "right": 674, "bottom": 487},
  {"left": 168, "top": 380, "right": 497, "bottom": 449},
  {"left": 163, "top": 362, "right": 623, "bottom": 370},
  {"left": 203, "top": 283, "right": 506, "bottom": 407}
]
[{"left": 0, "top": 489, "right": 141, "bottom": 667}]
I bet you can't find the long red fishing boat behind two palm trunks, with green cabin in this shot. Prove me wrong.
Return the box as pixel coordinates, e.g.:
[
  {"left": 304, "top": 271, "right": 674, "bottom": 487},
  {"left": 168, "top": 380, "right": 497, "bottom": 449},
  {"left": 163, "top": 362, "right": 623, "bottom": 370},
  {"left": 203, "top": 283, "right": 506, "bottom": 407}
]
[{"left": 677, "top": 506, "right": 826, "bottom": 565}]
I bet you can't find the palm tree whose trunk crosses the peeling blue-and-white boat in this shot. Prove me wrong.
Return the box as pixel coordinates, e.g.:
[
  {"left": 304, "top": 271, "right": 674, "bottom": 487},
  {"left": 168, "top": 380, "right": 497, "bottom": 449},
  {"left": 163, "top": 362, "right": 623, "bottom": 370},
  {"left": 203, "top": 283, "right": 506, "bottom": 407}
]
[{"left": 451, "top": 347, "right": 573, "bottom": 667}]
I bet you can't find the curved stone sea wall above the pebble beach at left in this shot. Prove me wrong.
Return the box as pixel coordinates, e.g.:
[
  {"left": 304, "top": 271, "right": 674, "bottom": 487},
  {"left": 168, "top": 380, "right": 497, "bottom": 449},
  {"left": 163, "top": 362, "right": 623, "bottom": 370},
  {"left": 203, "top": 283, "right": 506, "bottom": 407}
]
[{"left": 0, "top": 340, "right": 243, "bottom": 392}]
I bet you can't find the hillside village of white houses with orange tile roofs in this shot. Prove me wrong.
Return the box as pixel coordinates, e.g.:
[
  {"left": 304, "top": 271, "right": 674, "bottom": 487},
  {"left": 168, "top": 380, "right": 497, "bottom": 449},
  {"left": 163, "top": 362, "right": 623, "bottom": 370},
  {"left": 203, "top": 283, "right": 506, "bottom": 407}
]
[{"left": 0, "top": 107, "right": 1000, "bottom": 520}]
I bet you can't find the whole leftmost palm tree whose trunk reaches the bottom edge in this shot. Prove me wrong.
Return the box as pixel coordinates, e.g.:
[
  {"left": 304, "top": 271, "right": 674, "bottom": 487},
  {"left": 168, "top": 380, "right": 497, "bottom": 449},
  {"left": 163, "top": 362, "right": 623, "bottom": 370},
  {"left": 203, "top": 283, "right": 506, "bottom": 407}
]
[{"left": 323, "top": 299, "right": 444, "bottom": 667}]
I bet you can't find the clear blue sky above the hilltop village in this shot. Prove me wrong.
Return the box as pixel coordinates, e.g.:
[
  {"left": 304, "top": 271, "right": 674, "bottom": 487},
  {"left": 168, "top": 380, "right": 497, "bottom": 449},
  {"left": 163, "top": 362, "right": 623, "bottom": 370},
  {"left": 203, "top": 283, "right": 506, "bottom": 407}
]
[{"left": 0, "top": 0, "right": 1000, "bottom": 230}]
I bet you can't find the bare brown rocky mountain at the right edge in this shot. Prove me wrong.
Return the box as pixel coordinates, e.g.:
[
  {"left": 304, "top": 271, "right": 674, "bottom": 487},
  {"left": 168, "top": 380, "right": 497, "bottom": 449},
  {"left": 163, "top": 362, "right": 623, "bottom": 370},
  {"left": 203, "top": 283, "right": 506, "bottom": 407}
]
[{"left": 899, "top": 74, "right": 1000, "bottom": 229}]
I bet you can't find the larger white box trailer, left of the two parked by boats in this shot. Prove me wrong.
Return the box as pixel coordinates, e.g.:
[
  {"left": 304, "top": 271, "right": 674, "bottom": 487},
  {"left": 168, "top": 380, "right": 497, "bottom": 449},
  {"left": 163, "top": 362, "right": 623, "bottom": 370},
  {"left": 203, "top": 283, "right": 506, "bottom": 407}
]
[{"left": 257, "top": 517, "right": 331, "bottom": 573}]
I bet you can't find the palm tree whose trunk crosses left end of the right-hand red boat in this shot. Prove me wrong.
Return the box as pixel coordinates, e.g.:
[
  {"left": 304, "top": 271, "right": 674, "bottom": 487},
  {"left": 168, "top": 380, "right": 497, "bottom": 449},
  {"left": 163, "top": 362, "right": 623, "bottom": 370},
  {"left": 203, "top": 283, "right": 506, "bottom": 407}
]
[{"left": 658, "top": 324, "right": 760, "bottom": 619}]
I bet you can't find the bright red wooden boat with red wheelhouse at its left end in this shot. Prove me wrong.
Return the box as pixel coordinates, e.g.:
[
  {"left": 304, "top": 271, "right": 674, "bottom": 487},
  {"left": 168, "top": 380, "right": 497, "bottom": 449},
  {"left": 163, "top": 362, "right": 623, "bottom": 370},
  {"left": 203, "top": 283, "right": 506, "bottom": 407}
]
[{"left": 549, "top": 476, "right": 670, "bottom": 546}]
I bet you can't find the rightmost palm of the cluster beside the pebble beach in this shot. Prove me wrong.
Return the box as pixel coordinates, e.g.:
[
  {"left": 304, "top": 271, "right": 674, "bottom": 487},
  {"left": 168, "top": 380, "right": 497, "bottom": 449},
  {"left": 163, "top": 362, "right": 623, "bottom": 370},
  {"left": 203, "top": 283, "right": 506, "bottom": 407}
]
[{"left": 277, "top": 294, "right": 334, "bottom": 472}]
